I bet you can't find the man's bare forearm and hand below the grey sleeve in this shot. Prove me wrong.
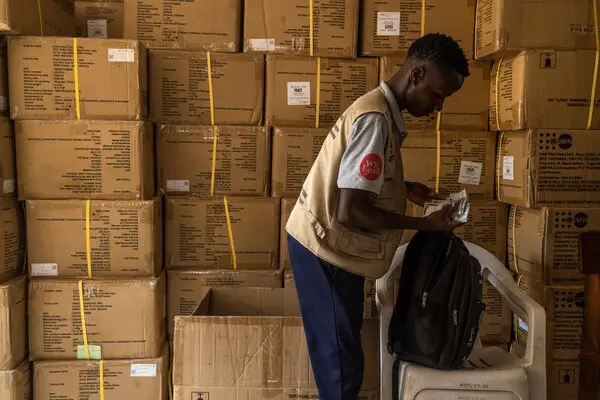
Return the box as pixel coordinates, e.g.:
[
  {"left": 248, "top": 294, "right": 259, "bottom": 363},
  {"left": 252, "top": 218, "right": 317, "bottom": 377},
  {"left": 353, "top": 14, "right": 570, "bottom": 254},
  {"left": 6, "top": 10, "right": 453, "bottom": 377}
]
[{"left": 337, "top": 189, "right": 461, "bottom": 232}]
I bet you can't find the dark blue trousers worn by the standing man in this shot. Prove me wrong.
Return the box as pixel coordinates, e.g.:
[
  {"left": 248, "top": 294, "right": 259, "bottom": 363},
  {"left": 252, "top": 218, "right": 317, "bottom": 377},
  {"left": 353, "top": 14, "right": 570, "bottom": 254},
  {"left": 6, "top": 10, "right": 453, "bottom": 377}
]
[{"left": 288, "top": 235, "right": 365, "bottom": 400}]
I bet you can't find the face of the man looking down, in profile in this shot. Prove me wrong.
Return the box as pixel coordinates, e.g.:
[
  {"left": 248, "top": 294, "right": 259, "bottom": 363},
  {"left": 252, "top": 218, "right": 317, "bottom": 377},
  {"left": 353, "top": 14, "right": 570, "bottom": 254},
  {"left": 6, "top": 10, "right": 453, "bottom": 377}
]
[{"left": 406, "top": 64, "right": 464, "bottom": 117}]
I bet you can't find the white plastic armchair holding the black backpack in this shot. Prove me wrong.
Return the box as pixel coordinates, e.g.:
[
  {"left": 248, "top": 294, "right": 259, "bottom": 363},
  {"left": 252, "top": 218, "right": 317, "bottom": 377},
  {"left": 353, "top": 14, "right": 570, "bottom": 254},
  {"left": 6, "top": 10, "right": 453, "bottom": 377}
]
[{"left": 376, "top": 242, "right": 546, "bottom": 400}]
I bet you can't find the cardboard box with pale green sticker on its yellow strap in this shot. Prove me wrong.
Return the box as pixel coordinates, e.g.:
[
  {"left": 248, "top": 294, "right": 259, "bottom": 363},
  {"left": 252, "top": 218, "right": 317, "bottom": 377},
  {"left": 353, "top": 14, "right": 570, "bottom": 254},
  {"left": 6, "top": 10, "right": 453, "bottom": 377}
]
[{"left": 28, "top": 274, "right": 167, "bottom": 361}]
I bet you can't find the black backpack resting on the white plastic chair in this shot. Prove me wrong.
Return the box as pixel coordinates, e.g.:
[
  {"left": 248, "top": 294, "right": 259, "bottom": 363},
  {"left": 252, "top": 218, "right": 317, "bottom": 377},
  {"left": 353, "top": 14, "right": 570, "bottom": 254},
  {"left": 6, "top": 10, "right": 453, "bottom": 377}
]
[{"left": 388, "top": 232, "right": 485, "bottom": 370}]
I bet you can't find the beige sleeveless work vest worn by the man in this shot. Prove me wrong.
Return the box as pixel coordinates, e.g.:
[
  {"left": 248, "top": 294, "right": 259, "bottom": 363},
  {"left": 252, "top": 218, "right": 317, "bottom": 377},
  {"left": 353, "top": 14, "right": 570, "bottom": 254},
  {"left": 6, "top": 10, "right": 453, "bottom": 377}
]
[{"left": 286, "top": 87, "right": 406, "bottom": 278}]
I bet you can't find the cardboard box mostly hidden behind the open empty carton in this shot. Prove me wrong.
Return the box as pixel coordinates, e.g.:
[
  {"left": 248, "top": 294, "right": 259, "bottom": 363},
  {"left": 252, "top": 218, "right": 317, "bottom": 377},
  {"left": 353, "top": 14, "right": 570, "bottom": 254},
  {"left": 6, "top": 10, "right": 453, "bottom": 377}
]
[{"left": 167, "top": 270, "right": 283, "bottom": 339}]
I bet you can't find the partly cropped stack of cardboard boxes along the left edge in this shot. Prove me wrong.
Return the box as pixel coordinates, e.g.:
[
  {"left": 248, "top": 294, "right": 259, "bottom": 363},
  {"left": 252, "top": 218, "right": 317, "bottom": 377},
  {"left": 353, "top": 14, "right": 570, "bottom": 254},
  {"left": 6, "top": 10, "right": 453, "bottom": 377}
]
[{"left": 0, "top": 0, "right": 75, "bottom": 400}]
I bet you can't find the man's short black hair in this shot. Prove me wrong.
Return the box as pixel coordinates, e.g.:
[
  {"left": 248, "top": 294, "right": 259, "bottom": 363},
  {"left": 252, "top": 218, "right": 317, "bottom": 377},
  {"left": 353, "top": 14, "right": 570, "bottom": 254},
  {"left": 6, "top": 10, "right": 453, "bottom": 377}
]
[{"left": 408, "top": 33, "right": 470, "bottom": 78}]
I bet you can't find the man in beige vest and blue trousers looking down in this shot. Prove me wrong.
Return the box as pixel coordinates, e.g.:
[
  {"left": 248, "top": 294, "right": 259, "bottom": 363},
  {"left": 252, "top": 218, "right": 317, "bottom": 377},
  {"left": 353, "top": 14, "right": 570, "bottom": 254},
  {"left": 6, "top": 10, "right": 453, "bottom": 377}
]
[{"left": 286, "top": 34, "right": 469, "bottom": 400}]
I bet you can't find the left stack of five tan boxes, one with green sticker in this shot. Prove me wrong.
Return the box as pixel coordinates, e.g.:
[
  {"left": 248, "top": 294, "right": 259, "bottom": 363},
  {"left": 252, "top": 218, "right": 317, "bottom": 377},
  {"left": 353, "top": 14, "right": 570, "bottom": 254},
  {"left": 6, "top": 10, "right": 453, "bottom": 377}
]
[{"left": 2, "top": 2, "right": 169, "bottom": 392}]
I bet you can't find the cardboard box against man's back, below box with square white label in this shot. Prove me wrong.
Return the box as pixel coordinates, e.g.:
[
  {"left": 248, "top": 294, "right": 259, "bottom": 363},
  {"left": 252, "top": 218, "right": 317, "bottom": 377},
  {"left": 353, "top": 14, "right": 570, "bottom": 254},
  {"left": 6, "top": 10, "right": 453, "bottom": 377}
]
[{"left": 271, "top": 128, "right": 329, "bottom": 197}]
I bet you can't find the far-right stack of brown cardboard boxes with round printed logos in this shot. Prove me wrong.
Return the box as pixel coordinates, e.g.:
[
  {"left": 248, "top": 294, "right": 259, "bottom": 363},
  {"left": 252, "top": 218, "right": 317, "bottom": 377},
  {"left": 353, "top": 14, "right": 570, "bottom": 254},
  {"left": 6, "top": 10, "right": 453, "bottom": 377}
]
[{"left": 476, "top": 0, "right": 600, "bottom": 400}]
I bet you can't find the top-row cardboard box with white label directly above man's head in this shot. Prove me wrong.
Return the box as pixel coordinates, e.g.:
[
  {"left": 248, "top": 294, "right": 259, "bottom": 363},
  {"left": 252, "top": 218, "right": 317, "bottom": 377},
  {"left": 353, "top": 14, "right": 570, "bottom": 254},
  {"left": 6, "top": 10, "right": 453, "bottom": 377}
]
[{"left": 360, "top": 0, "right": 475, "bottom": 59}]
